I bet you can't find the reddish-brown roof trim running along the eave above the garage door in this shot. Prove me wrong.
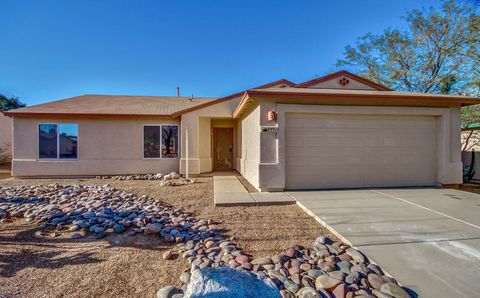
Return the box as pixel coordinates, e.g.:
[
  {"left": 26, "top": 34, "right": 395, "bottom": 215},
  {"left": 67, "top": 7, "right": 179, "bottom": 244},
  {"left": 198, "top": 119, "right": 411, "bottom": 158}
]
[{"left": 233, "top": 89, "right": 480, "bottom": 118}]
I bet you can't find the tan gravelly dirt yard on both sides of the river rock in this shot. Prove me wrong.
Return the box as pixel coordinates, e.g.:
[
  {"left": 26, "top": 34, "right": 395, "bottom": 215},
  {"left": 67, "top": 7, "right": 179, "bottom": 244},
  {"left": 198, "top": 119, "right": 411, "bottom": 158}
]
[{"left": 0, "top": 178, "right": 329, "bottom": 297}]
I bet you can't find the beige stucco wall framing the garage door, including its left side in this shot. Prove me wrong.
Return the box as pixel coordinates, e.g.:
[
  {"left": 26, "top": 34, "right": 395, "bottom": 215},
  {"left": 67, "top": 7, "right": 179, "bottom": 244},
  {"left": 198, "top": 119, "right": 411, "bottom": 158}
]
[{"left": 241, "top": 100, "right": 462, "bottom": 191}]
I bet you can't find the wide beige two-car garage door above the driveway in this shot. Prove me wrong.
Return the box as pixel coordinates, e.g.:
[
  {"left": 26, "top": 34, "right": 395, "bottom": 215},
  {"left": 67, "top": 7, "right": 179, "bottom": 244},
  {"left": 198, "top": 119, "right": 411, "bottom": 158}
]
[{"left": 285, "top": 114, "right": 436, "bottom": 189}]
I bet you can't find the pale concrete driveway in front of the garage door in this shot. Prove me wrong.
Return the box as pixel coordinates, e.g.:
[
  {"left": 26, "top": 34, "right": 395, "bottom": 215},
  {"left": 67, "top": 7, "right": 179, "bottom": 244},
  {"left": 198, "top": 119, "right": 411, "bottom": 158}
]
[{"left": 288, "top": 189, "right": 480, "bottom": 297}]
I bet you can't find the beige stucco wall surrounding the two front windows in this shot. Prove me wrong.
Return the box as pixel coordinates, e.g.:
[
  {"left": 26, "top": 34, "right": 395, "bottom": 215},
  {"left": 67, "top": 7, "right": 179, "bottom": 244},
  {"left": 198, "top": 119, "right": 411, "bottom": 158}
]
[{"left": 12, "top": 118, "right": 182, "bottom": 176}]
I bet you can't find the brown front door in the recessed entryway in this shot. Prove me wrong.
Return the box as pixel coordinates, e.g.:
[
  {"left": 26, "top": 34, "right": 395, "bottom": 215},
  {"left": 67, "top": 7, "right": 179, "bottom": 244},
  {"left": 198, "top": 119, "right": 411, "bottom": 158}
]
[{"left": 213, "top": 127, "right": 233, "bottom": 171}]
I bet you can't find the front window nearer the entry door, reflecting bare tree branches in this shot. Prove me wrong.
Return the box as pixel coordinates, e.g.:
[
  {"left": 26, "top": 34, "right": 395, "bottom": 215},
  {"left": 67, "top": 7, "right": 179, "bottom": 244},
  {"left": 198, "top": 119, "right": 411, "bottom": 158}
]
[{"left": 143, "top": 125, "right": 178, "bottom": 158}]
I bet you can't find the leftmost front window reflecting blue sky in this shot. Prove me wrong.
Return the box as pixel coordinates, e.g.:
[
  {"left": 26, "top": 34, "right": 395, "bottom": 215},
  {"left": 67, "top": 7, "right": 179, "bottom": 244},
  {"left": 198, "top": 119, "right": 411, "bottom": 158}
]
[{"left": 38, "top": 123, "right": 78, "bottom": 159}]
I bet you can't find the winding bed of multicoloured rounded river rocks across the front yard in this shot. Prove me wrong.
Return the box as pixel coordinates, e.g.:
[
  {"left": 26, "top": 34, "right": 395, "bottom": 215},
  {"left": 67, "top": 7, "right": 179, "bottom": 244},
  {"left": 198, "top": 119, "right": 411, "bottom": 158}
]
[{"left": 0, "top": 184, "right": 410, "bottom": 298}]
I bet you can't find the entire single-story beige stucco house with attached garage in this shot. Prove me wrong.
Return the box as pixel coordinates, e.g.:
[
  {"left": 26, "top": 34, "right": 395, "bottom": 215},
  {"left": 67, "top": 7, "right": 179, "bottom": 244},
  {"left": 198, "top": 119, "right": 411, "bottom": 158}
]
[{"left": 1, "top": 71, "right": 479, "bottom": 191}]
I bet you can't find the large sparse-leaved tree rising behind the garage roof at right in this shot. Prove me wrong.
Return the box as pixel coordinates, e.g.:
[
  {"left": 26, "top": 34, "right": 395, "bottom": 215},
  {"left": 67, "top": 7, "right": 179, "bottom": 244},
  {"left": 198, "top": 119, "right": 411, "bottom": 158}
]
[{"left": 337, "top": 0, "right": 480, "bottom": 149}]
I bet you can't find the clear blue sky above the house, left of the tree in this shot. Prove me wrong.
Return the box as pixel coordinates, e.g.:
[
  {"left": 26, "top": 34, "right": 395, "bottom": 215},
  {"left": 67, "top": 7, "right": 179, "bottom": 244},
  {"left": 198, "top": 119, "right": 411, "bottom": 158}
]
[{"left": 0, "top": 0, "right": 438, "bottom": 105}]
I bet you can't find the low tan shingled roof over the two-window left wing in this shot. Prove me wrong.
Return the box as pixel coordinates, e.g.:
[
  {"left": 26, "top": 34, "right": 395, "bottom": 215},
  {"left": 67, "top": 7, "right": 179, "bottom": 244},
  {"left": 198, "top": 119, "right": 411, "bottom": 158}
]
[{"left": 4, "top": 94, "right": 215, "bottom": 117}]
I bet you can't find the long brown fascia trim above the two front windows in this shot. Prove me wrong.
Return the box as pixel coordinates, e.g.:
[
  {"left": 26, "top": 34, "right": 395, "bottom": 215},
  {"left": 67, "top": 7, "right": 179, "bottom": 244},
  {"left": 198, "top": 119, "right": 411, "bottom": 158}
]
[{"left": 2, "top": 111, "right": 176, "bottom": 119}]
